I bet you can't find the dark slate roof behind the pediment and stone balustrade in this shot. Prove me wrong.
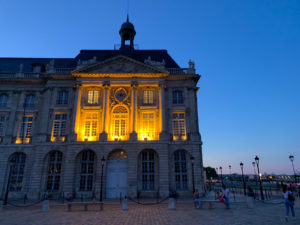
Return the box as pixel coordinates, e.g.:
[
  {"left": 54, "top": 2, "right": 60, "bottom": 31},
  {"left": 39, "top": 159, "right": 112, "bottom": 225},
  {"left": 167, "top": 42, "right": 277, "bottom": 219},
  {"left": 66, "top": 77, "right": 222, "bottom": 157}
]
[{"left": 0, "top": 50, "right": 180, "bottom": 73}]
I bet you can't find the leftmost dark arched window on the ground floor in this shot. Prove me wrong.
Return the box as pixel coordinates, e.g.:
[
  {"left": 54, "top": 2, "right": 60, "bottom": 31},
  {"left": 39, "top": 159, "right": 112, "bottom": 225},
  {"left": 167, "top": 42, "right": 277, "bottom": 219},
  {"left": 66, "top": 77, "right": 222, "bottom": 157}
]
[{"left": 9, "top": 152, "right": 26, "bottom": 191}]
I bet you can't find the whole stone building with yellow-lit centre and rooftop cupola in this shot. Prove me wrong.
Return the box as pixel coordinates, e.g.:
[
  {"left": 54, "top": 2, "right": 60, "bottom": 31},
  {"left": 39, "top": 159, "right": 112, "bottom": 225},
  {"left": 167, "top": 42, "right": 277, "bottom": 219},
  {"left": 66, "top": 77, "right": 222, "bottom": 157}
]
[{"left": 0, "top": 19, "right": 203, "bottom": 199}]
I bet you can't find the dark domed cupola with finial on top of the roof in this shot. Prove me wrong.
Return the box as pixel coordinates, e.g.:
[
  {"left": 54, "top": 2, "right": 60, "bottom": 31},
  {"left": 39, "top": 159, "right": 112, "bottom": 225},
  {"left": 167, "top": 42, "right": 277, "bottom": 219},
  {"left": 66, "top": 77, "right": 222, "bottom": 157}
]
[{"left": 119, "top": 15, "right": 136, "bottom": 50}]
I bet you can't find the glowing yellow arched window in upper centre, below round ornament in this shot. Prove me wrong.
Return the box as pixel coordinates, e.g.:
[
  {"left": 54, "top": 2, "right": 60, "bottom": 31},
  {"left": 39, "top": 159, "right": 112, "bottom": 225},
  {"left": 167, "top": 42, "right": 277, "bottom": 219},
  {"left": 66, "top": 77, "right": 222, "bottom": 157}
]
[{"left": 112, "top": 106, "right": 128, "bottom": 138}]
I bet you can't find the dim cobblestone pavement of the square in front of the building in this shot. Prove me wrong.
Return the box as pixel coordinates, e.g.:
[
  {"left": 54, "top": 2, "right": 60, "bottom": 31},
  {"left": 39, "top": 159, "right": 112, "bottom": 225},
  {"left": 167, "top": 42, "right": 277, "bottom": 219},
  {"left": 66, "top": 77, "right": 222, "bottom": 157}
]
[{"left": 0, "top": 201, "right": 300, "bottom": 225}]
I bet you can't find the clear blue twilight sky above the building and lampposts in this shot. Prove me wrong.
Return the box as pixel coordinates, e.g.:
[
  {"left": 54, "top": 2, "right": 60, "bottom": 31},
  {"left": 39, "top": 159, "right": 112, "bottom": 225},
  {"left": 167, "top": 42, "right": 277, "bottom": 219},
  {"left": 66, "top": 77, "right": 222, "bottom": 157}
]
[{"left": 0, "top": 0, "right": 300, "bottom": 173}]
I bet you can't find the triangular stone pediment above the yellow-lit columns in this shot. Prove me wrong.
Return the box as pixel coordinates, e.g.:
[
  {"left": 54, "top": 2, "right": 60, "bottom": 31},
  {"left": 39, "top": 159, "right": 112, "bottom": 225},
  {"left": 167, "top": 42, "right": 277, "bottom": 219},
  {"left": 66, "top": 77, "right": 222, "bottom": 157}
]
[{"left": 72, "top": 55, "right": 169, "bottom": 77}]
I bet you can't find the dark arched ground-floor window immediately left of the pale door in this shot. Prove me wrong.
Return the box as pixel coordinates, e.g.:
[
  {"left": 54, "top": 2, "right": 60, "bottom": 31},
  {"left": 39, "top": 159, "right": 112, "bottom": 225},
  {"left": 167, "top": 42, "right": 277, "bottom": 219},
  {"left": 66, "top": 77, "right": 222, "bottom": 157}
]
[{"left": 79, "top": 151, "right": 95, "bottom": 191}]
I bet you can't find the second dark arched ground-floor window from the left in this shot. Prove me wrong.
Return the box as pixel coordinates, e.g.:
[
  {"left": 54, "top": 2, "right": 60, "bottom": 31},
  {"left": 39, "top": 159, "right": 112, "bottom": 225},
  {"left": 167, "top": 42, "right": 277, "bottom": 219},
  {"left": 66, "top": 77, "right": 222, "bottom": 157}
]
[{"left": 47, "top": 151, "right": 62, "bottom": 191}]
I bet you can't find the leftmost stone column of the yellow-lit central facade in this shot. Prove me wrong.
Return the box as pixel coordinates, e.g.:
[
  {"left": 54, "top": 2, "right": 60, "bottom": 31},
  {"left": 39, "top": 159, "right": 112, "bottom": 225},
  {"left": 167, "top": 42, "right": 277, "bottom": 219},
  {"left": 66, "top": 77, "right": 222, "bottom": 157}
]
[{"left": 69, "top": 84, "right": 81, "bottom": 142}]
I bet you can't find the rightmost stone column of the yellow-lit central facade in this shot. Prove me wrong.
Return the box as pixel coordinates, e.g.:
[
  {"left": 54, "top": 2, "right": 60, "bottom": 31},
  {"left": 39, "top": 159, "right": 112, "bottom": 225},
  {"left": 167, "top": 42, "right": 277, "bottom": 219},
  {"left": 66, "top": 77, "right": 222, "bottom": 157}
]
[{"left": 159, "top": 83, "right": 169, "bottom": 141}]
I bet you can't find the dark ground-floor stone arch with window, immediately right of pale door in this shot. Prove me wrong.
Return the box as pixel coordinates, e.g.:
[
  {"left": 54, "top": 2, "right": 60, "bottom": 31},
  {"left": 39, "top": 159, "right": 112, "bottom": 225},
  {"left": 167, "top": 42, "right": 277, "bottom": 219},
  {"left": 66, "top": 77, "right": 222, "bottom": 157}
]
[{"left": 137, "top": 149, "right": 159, "bottom": 197}]
